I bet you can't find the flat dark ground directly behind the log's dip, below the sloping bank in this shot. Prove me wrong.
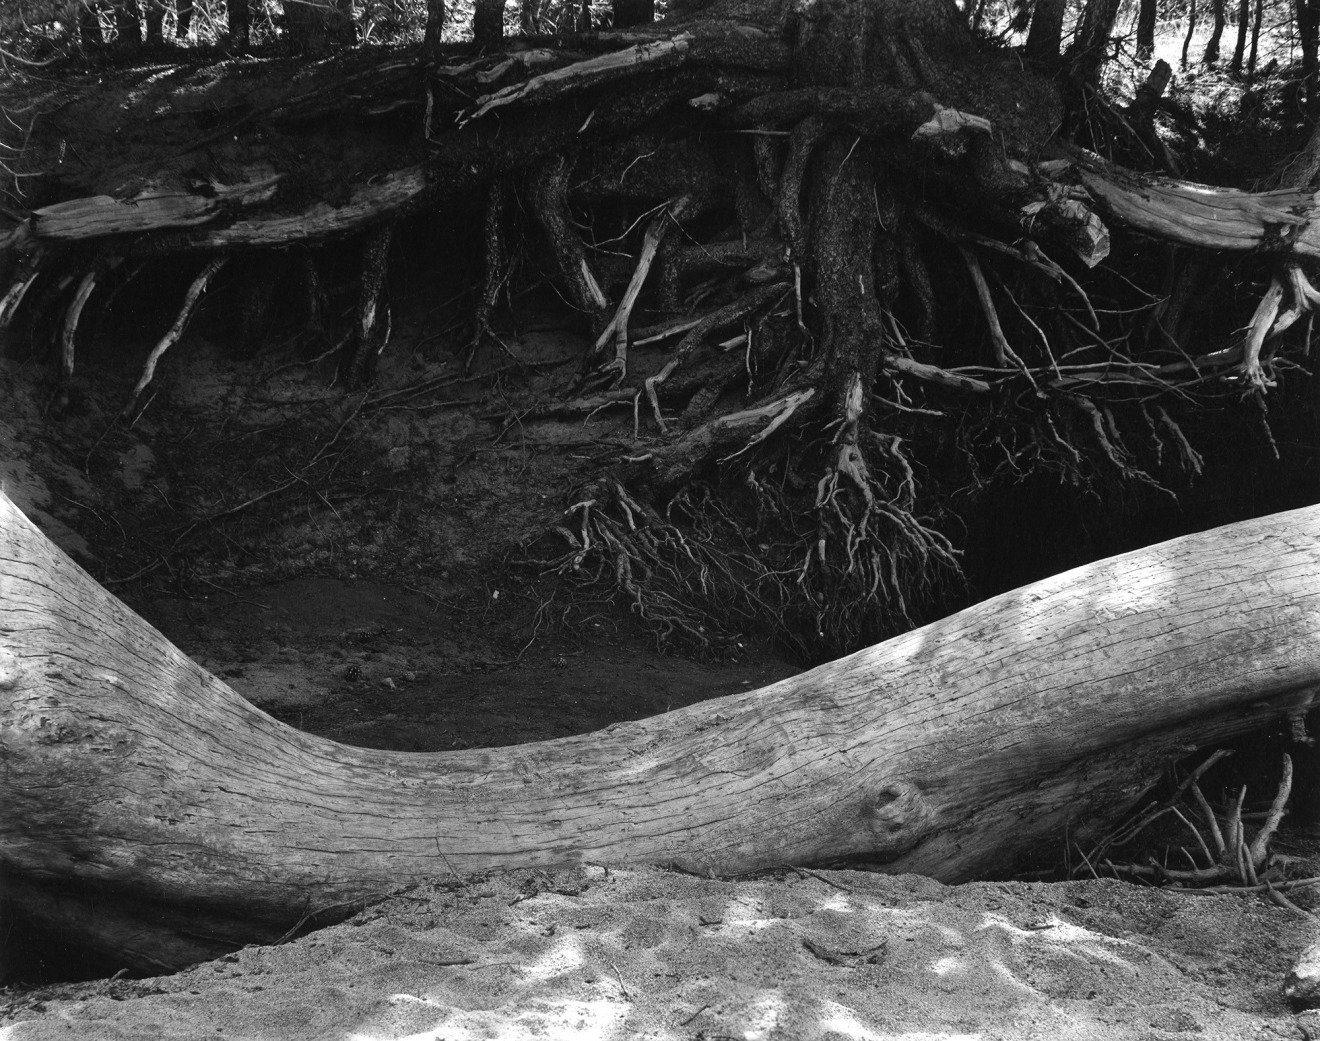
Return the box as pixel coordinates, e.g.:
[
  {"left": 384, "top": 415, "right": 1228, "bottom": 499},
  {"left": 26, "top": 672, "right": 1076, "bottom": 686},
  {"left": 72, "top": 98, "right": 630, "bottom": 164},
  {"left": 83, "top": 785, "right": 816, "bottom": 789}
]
[{"left": 131, "top": 578, "right": 796, "bottom": 752}]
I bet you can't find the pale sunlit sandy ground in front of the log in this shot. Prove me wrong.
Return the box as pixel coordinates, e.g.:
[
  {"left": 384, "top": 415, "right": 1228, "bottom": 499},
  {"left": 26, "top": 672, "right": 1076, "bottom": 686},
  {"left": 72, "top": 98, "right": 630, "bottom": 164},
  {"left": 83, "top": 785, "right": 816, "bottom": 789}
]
[{"left": 0, "top": 866, "right": 1320, "bottom": 1041}]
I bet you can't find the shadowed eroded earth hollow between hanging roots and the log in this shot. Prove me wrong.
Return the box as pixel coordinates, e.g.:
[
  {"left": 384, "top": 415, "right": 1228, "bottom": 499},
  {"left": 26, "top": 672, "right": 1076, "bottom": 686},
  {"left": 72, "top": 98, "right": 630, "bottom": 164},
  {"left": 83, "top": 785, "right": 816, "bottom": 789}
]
[{"left": 0, "top": 248, "right": 799, "bottom": 770}]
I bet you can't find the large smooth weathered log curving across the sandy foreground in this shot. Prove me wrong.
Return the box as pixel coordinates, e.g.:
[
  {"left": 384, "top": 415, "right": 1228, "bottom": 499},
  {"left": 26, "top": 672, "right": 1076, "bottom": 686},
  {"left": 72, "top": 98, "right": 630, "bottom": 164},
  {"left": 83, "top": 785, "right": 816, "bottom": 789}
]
[{"left": 0, "top": 496, "right": 1320, "bottom": 968}]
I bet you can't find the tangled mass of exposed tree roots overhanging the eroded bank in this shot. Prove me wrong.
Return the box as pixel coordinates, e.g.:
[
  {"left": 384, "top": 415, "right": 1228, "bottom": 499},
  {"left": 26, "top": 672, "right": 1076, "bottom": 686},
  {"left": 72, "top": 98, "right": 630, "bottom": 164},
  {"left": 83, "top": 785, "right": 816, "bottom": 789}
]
[{"left": 0, "top": 3, "right": 1320, "bottom": 656}]
